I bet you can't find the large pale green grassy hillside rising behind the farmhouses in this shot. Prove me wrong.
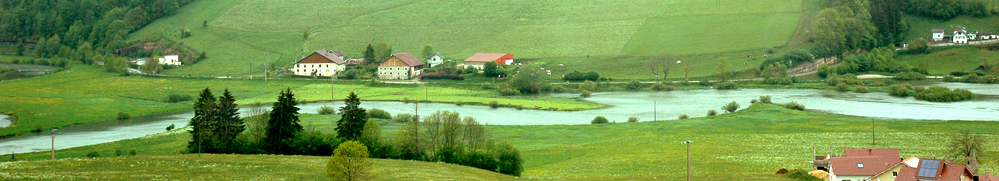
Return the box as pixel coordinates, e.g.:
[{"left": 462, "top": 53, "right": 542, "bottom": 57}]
[{"left": 130, "top": 0, "right": 802, "bottom": 75}]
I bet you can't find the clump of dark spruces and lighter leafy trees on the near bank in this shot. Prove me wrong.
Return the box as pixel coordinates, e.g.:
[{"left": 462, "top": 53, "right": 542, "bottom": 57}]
[{"left": 187, "top": 88, "right": 523, "bottom": 176}]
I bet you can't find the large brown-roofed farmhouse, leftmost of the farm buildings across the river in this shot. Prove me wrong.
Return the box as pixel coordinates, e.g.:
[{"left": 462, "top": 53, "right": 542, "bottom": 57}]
[{"left": 293, "top": 50, "right": 347, "bottom": 77}]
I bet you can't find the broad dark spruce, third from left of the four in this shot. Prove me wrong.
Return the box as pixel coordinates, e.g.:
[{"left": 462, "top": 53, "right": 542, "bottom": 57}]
[{"left": 264, "top": 89, "right": 302, "bottom": 153}]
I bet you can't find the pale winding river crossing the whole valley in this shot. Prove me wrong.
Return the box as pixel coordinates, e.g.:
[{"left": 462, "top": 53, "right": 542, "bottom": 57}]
[{"left": 0, "top": 83, "right": 999, "bottom": 154}]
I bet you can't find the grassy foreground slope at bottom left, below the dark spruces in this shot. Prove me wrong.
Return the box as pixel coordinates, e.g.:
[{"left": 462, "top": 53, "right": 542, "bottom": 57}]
[{"left": 0, "top": 154, "right": 517, "bottom": 180}]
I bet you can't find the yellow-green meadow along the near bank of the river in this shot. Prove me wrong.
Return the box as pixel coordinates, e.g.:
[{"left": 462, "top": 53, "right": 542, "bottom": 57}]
[{"left": 0, "top": 103, "right": 999, "bottom": 180}]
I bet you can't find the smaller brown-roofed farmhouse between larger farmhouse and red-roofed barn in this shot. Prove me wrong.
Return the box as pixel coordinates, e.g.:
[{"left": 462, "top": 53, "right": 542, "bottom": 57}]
[{"left": 378, "top": 53, "right": 423, "bottom": 80}]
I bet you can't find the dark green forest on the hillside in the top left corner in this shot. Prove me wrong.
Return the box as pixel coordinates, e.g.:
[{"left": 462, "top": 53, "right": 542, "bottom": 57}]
[{"left": 0, "top": 0, "right": 194, "bottom": 53}]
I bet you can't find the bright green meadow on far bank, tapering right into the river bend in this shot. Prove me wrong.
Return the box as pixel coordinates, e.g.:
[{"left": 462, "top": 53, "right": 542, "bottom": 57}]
[{"left": 0, "top": 60, "right": 602, "bottom": 135}]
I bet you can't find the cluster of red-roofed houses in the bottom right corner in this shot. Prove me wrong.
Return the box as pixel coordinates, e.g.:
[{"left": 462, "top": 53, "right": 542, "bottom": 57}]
[{"left": 809, "top": 148, "right": 999, "bottom": 181}]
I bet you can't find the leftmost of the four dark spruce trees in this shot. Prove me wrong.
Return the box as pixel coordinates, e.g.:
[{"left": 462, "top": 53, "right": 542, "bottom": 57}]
[{"left": 187, "top": 87, "right": 217, "bottom": 153}]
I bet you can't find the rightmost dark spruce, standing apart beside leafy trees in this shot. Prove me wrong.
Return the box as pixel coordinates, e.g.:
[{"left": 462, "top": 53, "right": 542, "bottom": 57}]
[{"left": 336, "top": 92, "right": 368, "bottom": 140}]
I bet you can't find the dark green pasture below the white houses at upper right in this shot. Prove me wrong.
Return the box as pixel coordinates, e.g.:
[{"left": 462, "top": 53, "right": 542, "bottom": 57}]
[{"left": 898, "top": 46, "right": 999, "bottom": 75}]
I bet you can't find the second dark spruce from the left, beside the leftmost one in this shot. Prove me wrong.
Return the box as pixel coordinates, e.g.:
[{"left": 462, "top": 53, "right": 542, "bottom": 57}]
[{"left": 213, "top": 89, "right": 246, "bottom": 151}]
